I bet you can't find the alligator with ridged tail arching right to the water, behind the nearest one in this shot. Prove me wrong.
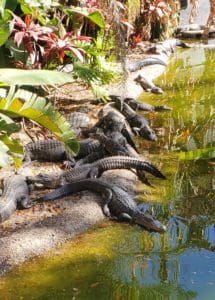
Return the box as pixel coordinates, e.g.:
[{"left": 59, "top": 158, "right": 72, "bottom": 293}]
[{"left": 27, "top": 156, "right": 166, "bottom": 188}]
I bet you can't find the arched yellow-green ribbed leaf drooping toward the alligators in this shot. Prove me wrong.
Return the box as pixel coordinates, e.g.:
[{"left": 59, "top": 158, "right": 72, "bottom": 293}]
[{"left": 0, "top": 87, "right": 79, "bottom": 154}]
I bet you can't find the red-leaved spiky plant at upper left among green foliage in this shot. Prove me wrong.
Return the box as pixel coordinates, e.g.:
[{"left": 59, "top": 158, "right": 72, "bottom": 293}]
[{"left": 12, "top": 15, "right": 91, "bottom": 69}]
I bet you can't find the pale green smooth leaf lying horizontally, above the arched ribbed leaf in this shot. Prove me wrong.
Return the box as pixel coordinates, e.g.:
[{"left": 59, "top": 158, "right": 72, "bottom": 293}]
[{"left": 0, "top": 68, "right": 74, "bottom": 86}]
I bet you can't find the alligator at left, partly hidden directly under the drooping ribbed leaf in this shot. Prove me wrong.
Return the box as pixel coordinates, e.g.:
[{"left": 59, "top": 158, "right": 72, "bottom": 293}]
[{"left": 24, "top": 139, "right": 75, "bottom": 167}]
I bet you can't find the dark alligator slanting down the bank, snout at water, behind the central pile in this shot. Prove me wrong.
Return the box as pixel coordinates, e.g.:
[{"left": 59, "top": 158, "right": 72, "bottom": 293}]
[{"left": 115, "top": 100, "right": 157, "bottom": 141}]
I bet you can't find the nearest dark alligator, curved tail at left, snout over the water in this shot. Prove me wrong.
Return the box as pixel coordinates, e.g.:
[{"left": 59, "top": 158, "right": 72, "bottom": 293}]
[{"left": 36, "top": 179, "right": 166, "bottom": 232}]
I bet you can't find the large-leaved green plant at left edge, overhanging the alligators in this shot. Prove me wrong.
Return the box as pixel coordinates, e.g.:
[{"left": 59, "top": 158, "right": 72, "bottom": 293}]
[{"left": 0, "top": 69, "right": 79, "bottom": 167}]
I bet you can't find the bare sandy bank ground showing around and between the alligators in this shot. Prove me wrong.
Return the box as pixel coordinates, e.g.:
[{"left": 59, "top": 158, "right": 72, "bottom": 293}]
[{"left": 0, "top": 44, "right": 167, "bottom": 275}]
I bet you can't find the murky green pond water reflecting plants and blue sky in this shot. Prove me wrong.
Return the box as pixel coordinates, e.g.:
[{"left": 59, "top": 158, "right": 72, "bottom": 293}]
[{"left": 0, "top": 49, "right": 215, "bottom": 300}]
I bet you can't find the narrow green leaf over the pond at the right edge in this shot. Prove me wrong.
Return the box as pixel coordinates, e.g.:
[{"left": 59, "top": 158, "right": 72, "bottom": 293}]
[{"left": 179, "top": 147, "right": 215, "bottom": 160}]
